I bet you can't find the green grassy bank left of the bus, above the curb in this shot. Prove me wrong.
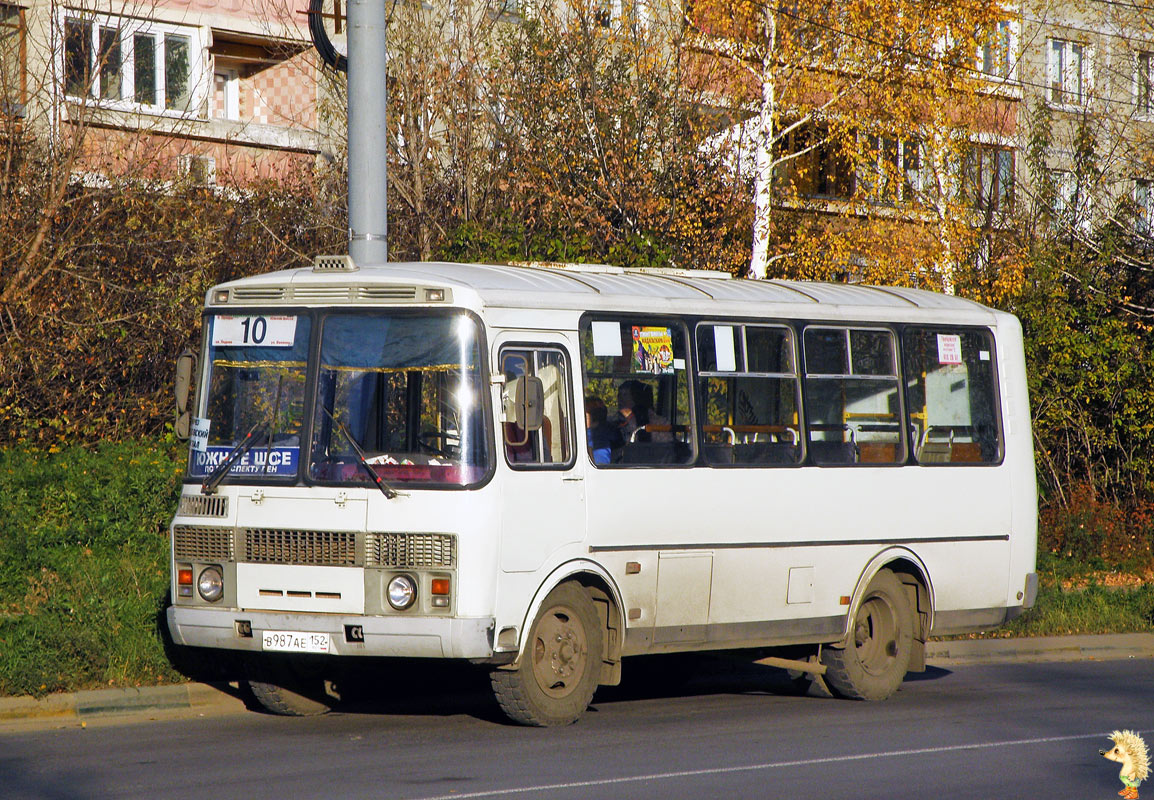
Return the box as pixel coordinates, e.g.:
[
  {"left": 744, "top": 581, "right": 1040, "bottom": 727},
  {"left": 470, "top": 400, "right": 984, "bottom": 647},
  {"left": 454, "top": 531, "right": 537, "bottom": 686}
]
[{"left": 0, "top": 439, "right": 183, "bottom": 695}]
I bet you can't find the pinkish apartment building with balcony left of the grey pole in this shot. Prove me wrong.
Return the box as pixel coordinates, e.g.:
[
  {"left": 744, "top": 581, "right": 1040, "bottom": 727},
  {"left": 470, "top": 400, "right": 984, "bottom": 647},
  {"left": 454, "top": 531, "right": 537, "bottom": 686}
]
[{"left": 0, "top": 0, "right": 324, "bottom": 185}]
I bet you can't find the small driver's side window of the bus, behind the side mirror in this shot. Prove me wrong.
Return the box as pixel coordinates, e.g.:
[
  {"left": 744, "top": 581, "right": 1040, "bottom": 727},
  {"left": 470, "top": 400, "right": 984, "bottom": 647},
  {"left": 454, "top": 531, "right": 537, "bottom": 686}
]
[{"left": 500, "top": 347, "right": 574, "bottom": 469}]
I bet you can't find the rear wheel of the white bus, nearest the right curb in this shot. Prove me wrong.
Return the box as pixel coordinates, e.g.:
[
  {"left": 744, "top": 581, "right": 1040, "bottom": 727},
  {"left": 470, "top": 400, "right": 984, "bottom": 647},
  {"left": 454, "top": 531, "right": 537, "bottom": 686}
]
[{"left": 822, "top": 569, "right": 914, "bottom": 700}]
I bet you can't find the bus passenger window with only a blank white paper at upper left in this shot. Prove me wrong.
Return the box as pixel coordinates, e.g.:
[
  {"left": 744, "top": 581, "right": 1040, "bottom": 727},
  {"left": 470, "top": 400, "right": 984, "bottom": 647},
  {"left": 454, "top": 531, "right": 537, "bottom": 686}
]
[{"left": 697, "top": 322, "right": 801, "bottom": 465}]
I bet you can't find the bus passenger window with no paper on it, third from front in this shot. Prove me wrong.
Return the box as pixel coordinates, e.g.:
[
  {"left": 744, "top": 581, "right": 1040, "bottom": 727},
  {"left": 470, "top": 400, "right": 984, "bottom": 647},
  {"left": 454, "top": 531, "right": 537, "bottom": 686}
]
[{"left": 804, "top": 327, "right": 906, "bottom": 464}]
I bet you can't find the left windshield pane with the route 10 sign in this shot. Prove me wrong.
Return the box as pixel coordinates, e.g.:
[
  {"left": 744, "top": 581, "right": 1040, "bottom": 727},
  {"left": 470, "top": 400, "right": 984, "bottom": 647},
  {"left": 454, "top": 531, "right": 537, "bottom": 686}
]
[{"left": 188, "top": 314, "right": 312, "bottom": 478}]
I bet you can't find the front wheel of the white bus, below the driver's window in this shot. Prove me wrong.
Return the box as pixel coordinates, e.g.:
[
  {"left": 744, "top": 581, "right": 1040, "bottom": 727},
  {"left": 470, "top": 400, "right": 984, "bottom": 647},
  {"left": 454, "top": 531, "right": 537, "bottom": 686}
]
[{"left": 489, "top": 583, "right": 604, "bottom": 727}]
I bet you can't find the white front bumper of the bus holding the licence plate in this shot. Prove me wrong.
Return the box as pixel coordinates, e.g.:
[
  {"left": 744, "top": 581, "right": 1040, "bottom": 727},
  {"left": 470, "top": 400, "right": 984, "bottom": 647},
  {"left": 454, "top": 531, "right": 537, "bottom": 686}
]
[{"left": 167, "top": 606, "right": 494, "bottom": 659}]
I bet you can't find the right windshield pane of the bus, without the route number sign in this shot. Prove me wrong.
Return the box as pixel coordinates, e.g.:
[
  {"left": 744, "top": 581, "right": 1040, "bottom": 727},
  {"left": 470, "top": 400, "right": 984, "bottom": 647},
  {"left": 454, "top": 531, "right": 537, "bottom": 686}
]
[{"left": 309, "top": 312, "right": 489, "bottom": 485}]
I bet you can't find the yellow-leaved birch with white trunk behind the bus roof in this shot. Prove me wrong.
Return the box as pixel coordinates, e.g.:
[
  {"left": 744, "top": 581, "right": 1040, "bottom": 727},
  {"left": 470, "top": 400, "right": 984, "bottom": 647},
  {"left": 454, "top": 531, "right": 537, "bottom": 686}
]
[{"left": 687, "top": 0, "right": 1004, "bottom": 286}]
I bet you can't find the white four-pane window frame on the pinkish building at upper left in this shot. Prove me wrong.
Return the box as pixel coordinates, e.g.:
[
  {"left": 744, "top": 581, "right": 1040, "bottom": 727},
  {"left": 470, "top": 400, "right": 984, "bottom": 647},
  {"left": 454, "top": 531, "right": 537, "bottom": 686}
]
[{"left": 57, "top": 9, "right": 211, "bottom": 118}]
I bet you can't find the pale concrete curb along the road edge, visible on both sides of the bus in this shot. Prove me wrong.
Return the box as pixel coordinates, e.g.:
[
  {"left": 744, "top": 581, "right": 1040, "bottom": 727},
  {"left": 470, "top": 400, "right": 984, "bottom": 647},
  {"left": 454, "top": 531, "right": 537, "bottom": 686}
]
[{"left": 0, "top": 634, "right": 1154, "bottom": 730}]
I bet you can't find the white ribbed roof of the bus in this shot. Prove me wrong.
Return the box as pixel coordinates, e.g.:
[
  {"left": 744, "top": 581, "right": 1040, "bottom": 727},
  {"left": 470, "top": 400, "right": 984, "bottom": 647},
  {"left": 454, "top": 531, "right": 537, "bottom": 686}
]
[{"left": 209, "top": 256, "right": 1006, "bottom": 321}]
